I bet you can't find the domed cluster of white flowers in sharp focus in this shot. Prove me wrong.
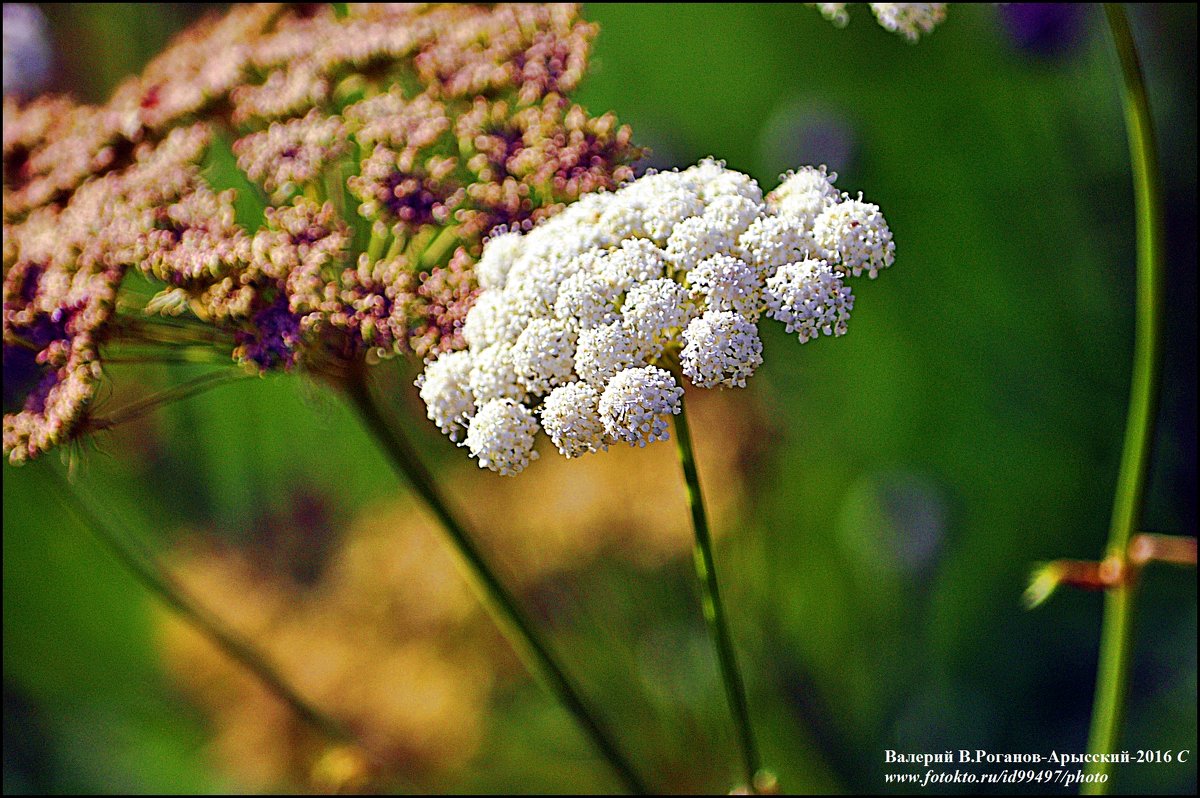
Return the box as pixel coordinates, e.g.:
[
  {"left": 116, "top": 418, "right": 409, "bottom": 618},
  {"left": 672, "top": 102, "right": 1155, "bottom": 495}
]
[{"left": 418, "top": 160, "right": 895, "bottom": 474}]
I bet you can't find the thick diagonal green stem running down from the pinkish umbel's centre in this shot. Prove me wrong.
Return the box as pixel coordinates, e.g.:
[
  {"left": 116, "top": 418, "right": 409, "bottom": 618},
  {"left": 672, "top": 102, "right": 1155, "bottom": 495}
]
[{"left": 344, "top": 370, "right": 648, "bottom": 794}]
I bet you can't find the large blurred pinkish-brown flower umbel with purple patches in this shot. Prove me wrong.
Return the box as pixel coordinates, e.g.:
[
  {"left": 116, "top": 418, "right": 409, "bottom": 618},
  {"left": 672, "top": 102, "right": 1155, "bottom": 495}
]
[{"left": 4, "top": 4, "right": 641, "bottom": 462}]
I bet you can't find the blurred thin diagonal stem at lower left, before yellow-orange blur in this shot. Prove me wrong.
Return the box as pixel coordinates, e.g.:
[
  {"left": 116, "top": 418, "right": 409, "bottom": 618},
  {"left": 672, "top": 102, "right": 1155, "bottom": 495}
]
[{"left": 46, "top": 468, "right": 358, "bottom": 744}]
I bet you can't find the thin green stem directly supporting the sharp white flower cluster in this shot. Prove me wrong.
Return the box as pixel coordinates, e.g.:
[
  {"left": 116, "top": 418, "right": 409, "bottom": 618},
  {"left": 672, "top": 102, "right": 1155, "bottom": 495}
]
[{"left": 674, "top": 401, "right": 761, "bottom": 791}]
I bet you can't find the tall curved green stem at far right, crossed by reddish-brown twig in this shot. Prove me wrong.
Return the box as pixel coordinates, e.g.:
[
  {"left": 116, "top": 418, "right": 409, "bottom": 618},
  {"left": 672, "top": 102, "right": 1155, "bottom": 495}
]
[{"left": 1082, "top": 2, "right": 1164, "bottom": 794}]
